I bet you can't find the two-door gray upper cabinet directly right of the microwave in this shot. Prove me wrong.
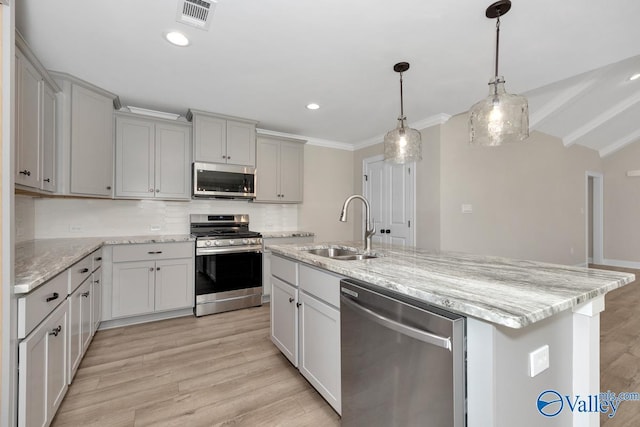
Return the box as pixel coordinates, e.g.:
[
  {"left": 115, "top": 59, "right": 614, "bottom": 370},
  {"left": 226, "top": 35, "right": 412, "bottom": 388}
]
[{"left": 255, "top": 135, "right": 305, "bottom": 203}]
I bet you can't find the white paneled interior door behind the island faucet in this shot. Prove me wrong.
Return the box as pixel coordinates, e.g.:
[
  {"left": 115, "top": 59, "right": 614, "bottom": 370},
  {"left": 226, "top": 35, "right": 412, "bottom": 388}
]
[{"left": 363, "top": 156, "right": 415, "bottom": 246}]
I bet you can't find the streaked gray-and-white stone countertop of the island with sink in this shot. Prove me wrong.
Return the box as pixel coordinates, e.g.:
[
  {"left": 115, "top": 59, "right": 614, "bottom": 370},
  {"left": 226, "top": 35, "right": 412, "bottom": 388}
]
[{"left": 269, "top": 242, "right": 635, "bottom": 328}]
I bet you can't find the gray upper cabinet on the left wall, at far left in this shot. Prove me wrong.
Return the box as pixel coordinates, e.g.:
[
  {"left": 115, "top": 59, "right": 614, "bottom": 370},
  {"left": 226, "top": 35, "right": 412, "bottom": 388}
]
[{"left": 15, "top": 35, "right": 59, "bottom": 192}]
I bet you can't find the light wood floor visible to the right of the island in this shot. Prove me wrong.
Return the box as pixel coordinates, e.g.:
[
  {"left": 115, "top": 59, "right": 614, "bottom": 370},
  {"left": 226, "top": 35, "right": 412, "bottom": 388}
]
[{"left": 592, "top": 265, "right": 640, "bottom": 427}]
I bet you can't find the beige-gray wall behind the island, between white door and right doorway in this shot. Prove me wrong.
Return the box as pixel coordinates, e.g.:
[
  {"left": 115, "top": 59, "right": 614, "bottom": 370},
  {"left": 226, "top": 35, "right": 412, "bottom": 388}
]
[{"left": 440, "top": 114, "right": 601, "bottom": 265}]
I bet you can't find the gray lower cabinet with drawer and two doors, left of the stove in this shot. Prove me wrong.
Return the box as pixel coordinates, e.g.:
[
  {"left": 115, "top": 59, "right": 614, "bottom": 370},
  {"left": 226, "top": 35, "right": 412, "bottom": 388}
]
[{"left": 105, "top": 242, "right": 194, "bottom": 319}]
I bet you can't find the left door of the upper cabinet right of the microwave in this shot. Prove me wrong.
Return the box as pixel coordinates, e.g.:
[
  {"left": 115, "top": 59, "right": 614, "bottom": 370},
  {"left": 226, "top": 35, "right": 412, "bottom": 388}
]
[{"left": 256, "top": 139, "right": 281, "bottom": 202}]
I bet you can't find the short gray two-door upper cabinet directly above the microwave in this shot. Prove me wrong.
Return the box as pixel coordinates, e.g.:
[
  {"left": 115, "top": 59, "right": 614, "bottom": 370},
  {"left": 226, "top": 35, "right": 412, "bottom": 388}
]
[{"left": 187, "top": 110, "right": 257, "bottom": 167}]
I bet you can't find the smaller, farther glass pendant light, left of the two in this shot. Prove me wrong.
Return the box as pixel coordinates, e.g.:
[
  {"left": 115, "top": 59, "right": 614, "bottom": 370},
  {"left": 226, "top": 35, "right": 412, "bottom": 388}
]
[{"left": 384, "top": 62, "right": 422, "bottom": 164}]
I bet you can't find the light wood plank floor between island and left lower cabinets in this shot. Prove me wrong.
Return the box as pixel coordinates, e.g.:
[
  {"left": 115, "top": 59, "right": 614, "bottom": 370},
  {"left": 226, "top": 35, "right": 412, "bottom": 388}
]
[{"left": 53, "top": 305, "right": 340, "bottom": 427}]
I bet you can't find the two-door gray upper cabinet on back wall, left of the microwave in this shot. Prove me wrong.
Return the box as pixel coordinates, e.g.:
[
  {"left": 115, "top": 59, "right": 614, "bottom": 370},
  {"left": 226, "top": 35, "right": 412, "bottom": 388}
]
[{"left": 115, "top": 113, "right": 191, "bottom": 200}]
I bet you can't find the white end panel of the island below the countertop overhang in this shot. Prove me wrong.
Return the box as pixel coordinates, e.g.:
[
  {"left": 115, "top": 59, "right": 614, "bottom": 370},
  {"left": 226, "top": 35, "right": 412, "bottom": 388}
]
[{"left": 467, "top": 310, "right": 574, "bottom": 427}]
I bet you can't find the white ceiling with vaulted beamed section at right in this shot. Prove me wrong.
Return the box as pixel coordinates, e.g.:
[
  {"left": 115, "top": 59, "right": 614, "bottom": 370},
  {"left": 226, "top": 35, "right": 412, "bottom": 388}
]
[{"left": 15, "top": 0, "right": 640, "bottom": 155}]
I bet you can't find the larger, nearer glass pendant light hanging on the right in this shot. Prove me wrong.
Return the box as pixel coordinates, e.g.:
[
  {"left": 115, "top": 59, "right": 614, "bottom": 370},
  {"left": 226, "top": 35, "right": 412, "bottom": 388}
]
[{"left": 469, "top": 0, "right": 529, "bottom": 146}]
